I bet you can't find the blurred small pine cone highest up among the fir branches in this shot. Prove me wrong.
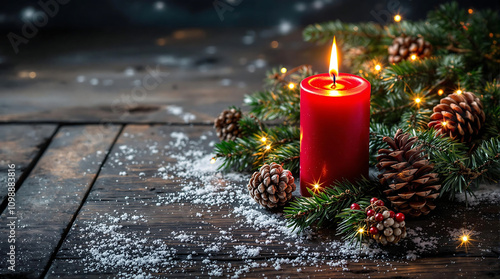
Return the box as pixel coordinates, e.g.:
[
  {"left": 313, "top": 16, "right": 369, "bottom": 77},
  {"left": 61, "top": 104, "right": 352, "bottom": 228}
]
[{"left": 387, "top": 34, "right": 432, "bottom": 63}]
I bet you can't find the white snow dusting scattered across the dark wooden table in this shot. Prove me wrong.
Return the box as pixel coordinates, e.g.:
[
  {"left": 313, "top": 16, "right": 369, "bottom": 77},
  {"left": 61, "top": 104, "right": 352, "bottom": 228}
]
[{"left": 63, "top": 128, "right": 500, "bottom": 278}]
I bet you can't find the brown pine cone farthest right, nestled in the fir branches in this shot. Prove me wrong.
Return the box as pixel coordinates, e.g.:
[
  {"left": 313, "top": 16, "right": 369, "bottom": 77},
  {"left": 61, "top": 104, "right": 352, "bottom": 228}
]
[{"left": 428, "top": 92, "right": 486, "bottom": 142}]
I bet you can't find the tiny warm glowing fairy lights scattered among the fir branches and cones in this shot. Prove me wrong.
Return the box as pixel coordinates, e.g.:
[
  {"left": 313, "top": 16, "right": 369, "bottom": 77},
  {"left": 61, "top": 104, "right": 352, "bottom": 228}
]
[{"left": 210, "top": 12, "right": 474, "bottom": 253}]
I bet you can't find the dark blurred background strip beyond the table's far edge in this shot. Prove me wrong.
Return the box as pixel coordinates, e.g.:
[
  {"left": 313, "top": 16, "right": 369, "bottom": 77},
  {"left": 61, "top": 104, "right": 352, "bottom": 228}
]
[{"left": 0, "top": 0, "right": 500, "bottom": 32}]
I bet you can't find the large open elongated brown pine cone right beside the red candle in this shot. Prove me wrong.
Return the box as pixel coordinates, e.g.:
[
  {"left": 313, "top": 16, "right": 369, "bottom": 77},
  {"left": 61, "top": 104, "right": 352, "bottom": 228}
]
[{"left": 377, "top": 129, "right": 441, "bottom": 217}]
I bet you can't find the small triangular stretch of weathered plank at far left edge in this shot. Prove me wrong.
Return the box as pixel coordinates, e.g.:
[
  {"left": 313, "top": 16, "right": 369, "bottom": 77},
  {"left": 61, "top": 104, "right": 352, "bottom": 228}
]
[{"left": 0, "top": 125, "right": 57, "bottom": 204}]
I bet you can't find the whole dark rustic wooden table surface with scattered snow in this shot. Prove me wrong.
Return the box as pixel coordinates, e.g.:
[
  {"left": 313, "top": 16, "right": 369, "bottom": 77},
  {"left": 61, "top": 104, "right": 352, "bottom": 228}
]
[{"left": 0, "top": 30, "right": 500, "bottom": 278}]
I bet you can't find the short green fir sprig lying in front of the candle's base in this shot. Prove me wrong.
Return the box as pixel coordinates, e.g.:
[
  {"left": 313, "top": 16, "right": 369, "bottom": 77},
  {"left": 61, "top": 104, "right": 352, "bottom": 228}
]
[{"left": 284, "top": 178, "right": 380, "bottom": 232}]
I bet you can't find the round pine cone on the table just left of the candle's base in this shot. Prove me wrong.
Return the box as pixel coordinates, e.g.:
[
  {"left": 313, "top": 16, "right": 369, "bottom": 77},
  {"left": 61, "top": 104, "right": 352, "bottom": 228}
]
[{"left": 247, "top": 163, "right": 296, "bottom": 208}]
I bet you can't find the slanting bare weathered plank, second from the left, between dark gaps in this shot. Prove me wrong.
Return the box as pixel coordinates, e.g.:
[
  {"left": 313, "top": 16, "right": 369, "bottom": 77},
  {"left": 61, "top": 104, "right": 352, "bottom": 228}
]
[{"left": 0, "top": 125, "right": 120, "bottom": 278}]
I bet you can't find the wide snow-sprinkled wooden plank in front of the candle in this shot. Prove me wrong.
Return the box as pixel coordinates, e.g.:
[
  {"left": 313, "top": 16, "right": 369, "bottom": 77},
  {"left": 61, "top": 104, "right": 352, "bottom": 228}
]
[{"left": 47, "top": 125, "right": 500, "bottom": 278}]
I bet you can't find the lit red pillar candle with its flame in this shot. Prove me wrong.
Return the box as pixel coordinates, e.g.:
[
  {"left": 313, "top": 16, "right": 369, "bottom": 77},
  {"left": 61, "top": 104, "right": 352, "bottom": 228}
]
[{"left": 300, "top": 39, "right": 370, "bottom": 196}]
